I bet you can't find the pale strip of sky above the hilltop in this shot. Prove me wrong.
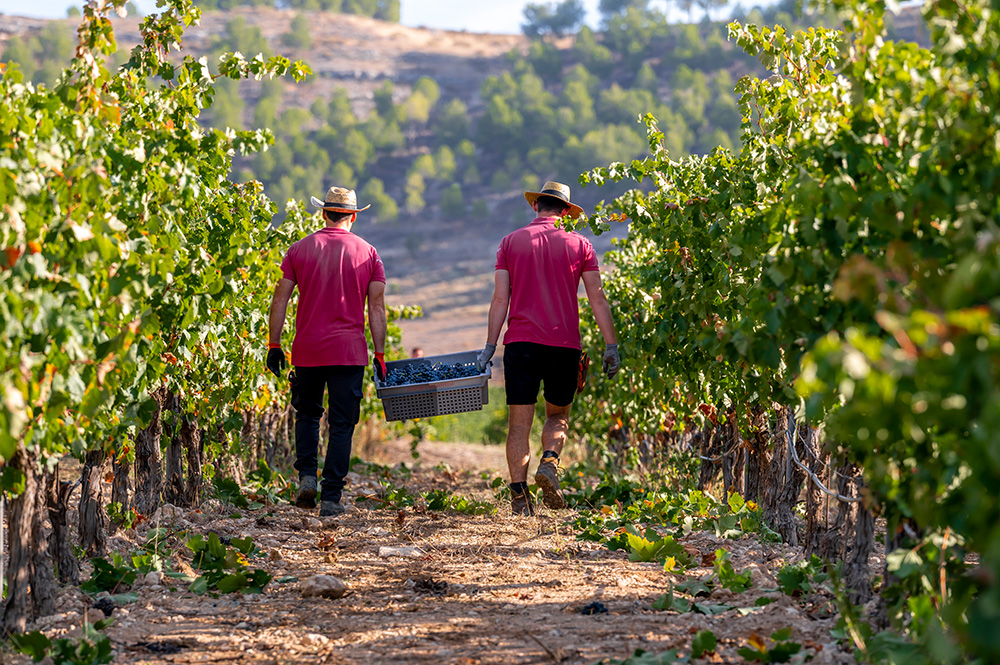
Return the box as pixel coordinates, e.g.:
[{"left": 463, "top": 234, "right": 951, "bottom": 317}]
[{"left": 0, "top": 0, "right": 736, "bottom": 34}]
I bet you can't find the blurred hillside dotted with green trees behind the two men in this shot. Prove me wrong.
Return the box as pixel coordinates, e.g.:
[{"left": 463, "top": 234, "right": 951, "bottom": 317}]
[{"left": 0, "top": 4, "right": 921, "bottom": 353}]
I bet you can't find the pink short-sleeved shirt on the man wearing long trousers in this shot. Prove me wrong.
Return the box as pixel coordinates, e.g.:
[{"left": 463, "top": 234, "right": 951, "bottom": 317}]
[{"left": 281, "top": 228, "right": 385, "bottom": 367}]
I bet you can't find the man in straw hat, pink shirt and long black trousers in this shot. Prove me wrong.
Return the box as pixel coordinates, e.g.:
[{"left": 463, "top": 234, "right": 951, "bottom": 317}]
[{"left": 267, "top": 187, "right": 386, "bottom": 517}]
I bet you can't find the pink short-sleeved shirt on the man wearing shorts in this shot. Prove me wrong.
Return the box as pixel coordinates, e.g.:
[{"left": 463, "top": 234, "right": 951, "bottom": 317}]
[{"left": 496, "top": 217, "right": 599, "bottom": 349}]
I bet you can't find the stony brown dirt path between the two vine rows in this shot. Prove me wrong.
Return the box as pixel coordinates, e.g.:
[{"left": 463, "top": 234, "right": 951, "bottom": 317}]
[{"left": 0, "top": 444, "right": 852, "bottom": 665}]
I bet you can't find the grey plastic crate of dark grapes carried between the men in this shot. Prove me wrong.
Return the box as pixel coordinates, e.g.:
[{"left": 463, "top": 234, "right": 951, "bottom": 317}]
[{"left": 375, "top": 351, "right": 491, "bottom": 421}]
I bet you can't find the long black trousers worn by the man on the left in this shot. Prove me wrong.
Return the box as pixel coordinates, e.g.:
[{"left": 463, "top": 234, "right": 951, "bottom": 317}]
[{"left": 292, "top": 365, "right": 365, "bottom": 502}]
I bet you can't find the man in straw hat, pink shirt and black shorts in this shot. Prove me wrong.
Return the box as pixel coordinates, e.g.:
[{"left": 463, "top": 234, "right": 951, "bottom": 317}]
[{"left": 479, "top": 182, "right": 620, "bottom": 515}]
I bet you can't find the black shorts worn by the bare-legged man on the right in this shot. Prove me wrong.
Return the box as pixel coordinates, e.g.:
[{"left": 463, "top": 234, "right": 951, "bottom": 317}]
[{"left": 503, "top": 342, "right": 580, "bottom": 406}]
